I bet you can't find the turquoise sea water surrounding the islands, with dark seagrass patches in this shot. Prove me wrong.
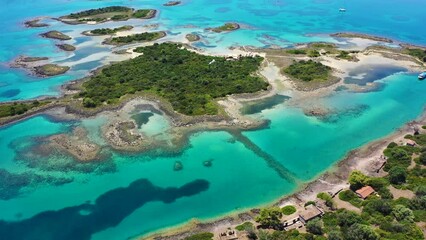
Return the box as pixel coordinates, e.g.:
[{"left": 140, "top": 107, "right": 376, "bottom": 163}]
[{"left": 0, "top": 0, "right": 426, "bottom": 239}]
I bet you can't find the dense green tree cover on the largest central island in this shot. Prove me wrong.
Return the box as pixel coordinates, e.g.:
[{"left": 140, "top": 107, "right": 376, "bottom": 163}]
[{"left": 79, "top": 43, "right": 268, "bottom": 115}]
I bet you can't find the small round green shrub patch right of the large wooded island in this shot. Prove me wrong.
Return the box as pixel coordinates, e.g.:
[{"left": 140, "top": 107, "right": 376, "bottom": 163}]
[{"left": 284, "top": 60, "right": 331, "bottom": 82}]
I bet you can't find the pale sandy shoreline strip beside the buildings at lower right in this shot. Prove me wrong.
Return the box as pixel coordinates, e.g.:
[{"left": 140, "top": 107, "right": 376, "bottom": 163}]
[{"left": 139, "top": 110, "right": 426, "bottom": 240}]
